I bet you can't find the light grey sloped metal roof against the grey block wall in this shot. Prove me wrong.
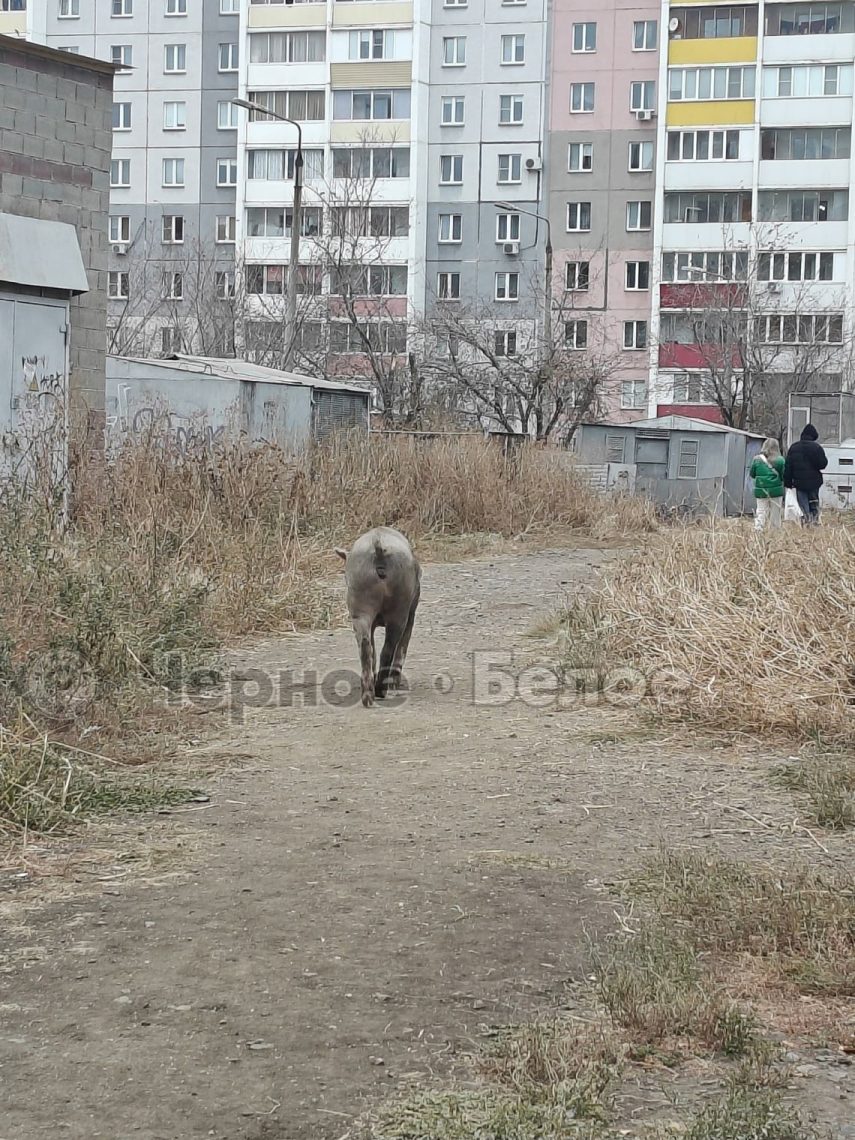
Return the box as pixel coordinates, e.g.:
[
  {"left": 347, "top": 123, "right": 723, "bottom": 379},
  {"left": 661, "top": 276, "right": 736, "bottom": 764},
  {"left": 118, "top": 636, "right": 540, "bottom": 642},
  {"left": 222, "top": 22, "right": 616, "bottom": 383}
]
[{"left": 0, "top": 213, "right": 89, "bottom": 293}]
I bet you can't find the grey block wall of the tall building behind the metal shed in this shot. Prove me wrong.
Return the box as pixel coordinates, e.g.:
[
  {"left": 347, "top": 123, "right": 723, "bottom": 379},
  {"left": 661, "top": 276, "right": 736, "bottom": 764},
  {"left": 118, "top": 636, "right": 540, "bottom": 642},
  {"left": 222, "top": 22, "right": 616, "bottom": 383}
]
[{"left": 0, "top": 38, "right": 113, "bottom": 412}]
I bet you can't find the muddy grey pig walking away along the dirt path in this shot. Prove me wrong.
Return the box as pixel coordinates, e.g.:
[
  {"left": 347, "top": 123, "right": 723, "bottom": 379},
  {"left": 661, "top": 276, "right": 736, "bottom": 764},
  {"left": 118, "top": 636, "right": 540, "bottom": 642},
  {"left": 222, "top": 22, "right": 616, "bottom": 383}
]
[{"left": 335, "top": 527, "right": 422, "bottom": 708}]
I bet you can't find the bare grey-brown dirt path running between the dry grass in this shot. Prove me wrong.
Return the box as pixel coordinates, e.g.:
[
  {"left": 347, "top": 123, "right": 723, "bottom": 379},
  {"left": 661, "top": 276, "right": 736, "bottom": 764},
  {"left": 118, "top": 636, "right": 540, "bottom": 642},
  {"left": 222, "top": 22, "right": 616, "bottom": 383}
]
[{"left": 0, "top": 549, "right": 855, "bottom": 1140}]
